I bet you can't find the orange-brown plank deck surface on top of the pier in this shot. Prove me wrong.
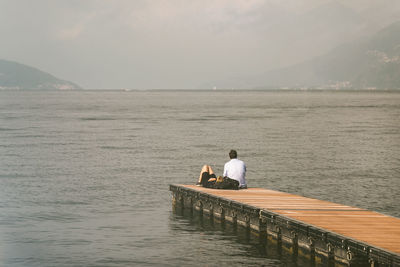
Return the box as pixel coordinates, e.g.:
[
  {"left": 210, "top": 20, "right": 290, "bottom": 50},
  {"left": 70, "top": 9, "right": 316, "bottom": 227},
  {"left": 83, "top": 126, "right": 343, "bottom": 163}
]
[{"left": 181, "top": 185, "right": 400, "bottom": 254}]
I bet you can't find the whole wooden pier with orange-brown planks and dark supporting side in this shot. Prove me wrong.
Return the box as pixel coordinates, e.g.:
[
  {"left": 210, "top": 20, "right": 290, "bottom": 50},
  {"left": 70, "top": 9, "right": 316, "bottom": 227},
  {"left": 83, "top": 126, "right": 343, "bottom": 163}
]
[{"left": 170, "top": 185, "right": 400, "bottom": 266}]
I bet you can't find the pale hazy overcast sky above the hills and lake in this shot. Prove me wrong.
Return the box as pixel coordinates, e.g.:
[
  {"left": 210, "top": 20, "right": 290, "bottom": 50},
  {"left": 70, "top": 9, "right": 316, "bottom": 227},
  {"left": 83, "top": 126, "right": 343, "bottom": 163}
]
[{"left": 0, "top": 0, "right": 400, "bottom": 89}]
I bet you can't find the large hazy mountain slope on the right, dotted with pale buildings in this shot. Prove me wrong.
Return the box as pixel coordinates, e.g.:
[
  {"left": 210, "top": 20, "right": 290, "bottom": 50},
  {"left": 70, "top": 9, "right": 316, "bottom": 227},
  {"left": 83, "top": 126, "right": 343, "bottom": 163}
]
[{"left": 250, "top": 22, "right": 400, "bottom": 89}]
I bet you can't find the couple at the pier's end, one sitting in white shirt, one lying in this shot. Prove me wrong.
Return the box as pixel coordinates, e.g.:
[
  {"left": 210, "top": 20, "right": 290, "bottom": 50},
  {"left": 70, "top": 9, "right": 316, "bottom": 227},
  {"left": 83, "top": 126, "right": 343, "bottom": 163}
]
[{"left": 197, "top": 150, "right": 247, "bottom": 190}]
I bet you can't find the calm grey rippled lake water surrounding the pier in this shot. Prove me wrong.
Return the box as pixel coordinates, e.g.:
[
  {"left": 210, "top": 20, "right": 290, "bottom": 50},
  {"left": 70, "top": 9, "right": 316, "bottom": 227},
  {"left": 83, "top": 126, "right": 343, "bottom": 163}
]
[{"left": 0, "top": 91, "right": 400, "bottom": 266}]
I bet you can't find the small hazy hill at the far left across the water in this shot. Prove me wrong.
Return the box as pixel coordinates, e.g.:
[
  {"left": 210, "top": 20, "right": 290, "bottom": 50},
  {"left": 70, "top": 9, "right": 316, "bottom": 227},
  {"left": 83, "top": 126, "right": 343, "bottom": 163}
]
[{"left": 0, "top": 59, "right": 81, "bottom": 90}]
